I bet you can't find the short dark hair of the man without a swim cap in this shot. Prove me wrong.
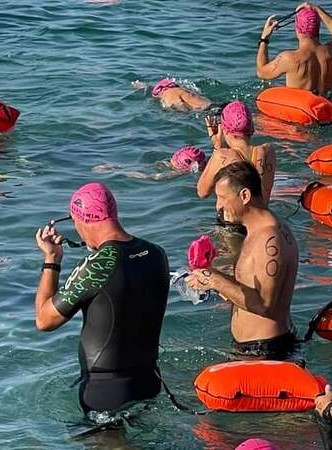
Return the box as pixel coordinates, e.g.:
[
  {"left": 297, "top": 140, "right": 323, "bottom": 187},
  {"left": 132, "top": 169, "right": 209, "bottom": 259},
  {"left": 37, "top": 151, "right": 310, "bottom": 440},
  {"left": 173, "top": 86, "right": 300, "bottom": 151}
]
[{"left": 213, "top": 161, "right": 262, "bottom": 197}]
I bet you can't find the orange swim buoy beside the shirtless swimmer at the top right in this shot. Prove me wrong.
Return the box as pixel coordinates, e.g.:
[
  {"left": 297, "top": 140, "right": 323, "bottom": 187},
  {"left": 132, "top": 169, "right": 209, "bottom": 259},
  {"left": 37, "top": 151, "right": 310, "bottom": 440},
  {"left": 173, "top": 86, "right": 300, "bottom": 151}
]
[{"left": 256, "top": 86, "right": 332, "bottom": 125}]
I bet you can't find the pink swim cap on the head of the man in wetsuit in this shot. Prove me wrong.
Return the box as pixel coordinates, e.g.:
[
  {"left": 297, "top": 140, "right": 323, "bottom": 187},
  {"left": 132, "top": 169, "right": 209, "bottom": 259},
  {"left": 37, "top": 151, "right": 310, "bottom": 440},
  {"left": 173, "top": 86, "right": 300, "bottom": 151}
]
[{"left": 70, "top": 183, "right": 118, "bottom": 223}]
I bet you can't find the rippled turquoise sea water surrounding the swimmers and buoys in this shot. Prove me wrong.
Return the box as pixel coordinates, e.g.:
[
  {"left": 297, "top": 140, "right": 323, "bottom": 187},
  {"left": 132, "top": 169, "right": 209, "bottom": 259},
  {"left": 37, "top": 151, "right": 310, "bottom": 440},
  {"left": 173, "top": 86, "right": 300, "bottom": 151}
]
[{"left": 0, "top": 0, "right": 332, "bottom": 450}]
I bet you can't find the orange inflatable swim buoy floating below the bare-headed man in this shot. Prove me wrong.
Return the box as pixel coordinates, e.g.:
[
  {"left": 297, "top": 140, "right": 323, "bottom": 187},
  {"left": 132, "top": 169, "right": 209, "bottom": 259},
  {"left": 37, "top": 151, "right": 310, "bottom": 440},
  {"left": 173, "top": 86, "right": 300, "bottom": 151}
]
[{"left": 194, "top": 361, "right": 326, "bottom": 412}]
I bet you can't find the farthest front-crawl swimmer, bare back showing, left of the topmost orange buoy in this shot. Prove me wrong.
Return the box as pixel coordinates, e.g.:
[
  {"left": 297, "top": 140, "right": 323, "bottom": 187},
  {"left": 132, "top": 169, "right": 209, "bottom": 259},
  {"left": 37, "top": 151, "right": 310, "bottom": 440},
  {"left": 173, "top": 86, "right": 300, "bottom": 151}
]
[{"left": 132, "top": 78, "right": 214, "bottom": 111}]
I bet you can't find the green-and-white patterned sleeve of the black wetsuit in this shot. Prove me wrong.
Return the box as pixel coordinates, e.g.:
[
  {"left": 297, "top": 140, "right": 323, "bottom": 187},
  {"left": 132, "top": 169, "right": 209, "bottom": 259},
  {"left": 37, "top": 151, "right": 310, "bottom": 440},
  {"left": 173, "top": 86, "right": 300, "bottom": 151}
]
[{"left": 53, "top": 246, "right": 118, "bottom": 319}]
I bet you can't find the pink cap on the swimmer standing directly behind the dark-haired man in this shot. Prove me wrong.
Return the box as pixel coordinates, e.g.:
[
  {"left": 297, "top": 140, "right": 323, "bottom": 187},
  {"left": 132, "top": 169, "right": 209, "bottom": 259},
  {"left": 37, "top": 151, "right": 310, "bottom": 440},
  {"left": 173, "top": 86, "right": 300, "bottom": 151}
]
[{"left": 221, "top": 100, "right": 254, "bottom": 136}]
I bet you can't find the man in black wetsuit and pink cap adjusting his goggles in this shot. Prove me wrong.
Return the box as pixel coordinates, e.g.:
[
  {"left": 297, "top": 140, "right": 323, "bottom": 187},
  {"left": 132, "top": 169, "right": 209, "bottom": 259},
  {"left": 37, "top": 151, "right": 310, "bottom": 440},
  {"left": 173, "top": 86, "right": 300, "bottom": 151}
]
[{"left": 35, "top": 183, "right": 169, "bottom": 413}]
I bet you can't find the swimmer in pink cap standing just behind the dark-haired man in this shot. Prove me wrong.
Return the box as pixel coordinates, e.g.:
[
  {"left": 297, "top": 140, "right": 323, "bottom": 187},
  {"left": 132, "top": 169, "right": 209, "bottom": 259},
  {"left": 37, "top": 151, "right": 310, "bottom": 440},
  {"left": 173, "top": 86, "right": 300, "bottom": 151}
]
[{"left": 197, "top": 100, "right": 276, "bottom": 206}]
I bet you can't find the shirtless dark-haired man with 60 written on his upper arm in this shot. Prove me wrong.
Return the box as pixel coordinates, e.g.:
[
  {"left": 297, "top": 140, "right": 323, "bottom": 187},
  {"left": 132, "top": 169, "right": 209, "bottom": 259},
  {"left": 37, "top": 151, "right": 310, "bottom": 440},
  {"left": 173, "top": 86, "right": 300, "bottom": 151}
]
[{"left": 186, "top": 161, "right": 298, "bottom": 360}]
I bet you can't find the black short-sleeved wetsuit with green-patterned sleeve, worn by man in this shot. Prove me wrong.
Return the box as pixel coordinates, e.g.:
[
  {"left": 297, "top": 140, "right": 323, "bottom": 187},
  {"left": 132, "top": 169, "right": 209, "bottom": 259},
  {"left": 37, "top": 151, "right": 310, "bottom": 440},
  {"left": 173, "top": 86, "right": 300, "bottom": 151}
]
[{"left": 53, "top": 238, "right": 169, "bottom": 413}]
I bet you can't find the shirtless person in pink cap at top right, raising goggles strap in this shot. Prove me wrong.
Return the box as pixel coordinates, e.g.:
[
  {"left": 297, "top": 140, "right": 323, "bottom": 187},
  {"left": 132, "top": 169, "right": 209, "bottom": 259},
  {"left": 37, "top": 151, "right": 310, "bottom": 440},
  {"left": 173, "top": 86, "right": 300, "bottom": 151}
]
[{"left": 256, "top": 3, "right": 332, "bottom": 95}]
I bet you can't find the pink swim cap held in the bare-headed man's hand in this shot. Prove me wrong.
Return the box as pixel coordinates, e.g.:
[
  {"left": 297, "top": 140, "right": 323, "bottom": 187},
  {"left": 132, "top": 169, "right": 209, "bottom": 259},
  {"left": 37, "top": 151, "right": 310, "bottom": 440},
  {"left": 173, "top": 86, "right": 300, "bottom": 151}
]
[{"left": 188, "top": 234, "right": 217, "bottom": 270}]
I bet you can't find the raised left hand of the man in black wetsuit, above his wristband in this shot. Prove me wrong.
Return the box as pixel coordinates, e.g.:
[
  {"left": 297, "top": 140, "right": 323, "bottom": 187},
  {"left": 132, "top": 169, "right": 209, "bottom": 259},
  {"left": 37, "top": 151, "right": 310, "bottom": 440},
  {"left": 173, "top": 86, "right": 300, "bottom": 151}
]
[{"left": 36, "top": 225, "right": 63, "bottom": 264}]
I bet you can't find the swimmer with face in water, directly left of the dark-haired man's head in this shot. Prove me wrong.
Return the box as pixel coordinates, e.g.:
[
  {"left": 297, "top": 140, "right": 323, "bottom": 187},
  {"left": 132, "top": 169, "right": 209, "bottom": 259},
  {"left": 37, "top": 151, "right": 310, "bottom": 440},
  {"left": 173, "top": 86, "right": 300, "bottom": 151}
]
[{"left": 92, "top": 145, "right": 206, "bottom": 181}]
